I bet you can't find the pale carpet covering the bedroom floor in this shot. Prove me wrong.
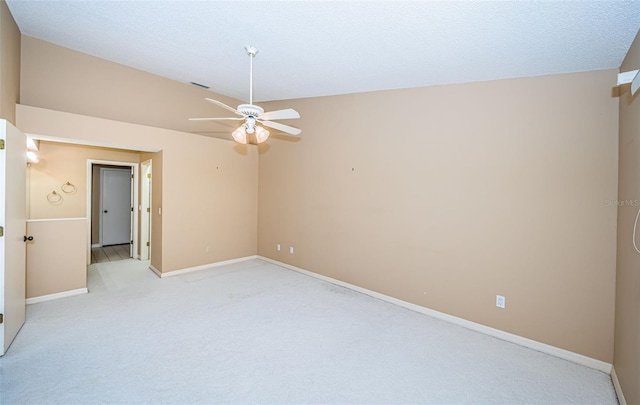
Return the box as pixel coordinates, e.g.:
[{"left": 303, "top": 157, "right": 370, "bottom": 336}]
[{"left": 0, "top": 260, "right": 617, "bottom": 405}]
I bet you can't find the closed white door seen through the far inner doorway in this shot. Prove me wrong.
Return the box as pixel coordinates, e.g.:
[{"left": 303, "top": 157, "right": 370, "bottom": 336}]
[{"left": 100, "top": 168, "right": 132, "bottom": 246}]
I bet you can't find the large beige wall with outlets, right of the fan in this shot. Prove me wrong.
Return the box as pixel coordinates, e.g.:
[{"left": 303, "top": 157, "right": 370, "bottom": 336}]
[{"left": 258, "top": 70, "right": 618, "bottom": 362}]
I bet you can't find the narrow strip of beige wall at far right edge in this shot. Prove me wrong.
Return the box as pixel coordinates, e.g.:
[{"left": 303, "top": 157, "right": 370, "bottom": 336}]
[{"left": 613, "top": 29, "right": 640, "bottom": 404}]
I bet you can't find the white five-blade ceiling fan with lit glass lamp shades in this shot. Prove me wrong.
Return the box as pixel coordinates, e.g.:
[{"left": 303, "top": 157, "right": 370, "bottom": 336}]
[{"left": 189, "top": 46, "right": 302, "bottom": 144}]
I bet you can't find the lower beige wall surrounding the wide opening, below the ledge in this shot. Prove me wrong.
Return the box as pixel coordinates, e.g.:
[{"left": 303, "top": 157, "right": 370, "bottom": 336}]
[{"left": 17, "top": 105, "right": 258, "bottom": 272}]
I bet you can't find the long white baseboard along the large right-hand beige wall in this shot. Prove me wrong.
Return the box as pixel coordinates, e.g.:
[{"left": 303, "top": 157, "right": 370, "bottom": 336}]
[{"left": 258, "top": 256, "right": 612, "bottom": 374}]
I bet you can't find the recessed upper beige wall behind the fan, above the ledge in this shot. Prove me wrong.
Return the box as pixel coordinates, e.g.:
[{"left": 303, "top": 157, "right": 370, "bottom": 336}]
[{"left": 20, "top": 36, "right": 240, "bottom": 139}]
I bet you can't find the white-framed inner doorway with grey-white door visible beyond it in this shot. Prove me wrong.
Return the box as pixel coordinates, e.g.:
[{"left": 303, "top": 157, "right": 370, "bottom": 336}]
[{"left": 87, "top": 159, "right": 138, "bottom": 264}]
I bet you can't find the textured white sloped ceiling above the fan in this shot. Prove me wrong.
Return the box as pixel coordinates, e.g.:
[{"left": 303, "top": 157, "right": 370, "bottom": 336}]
[{"left": 7, "top": 0, "right": 640, "bottom": 101}]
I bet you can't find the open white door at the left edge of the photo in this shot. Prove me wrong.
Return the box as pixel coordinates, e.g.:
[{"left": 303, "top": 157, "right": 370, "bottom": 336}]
[{"left": 0, "top": 120, "right": 27, "bottom": 355}]
